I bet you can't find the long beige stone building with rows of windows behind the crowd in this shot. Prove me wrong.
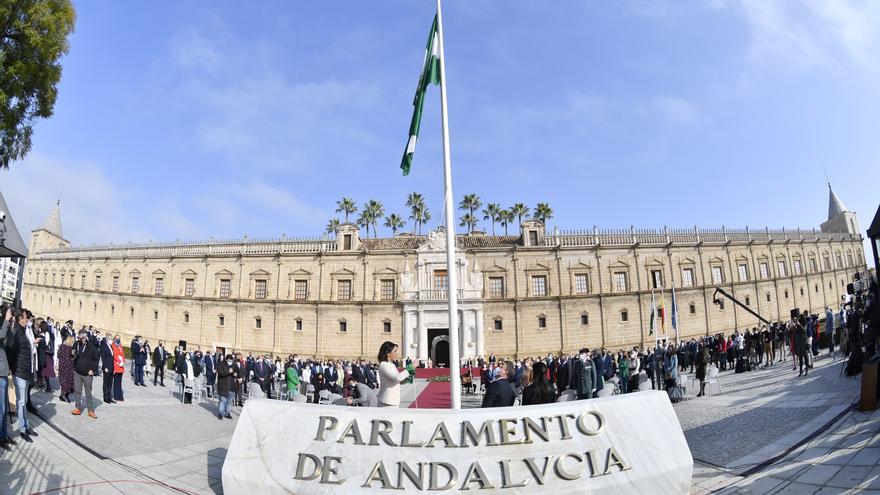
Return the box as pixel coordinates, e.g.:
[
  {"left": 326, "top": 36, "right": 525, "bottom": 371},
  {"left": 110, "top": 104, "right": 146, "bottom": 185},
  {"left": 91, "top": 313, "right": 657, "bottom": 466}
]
[{"left": 18, "top": 188, "right": 866, "bottom": 363}]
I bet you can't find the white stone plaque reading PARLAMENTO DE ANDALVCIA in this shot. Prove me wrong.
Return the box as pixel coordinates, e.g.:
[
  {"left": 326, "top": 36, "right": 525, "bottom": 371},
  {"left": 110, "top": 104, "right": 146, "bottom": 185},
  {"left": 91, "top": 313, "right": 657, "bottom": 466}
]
[{"left": 223, "top": 391, "right": 693, "bottom": 495}]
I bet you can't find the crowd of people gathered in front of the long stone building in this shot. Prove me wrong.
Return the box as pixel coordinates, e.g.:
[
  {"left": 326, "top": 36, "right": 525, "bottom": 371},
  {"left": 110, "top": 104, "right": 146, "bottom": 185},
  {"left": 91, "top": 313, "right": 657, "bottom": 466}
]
[{"left": 0, "top": 278, "right": 880, "bottom": 450}]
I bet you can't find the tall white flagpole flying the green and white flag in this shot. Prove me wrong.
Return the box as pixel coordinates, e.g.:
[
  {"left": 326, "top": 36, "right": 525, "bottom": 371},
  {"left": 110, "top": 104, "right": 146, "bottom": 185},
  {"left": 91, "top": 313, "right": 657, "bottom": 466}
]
[{"left": 437, "top": 0, "right": 461, "bottom": 409}]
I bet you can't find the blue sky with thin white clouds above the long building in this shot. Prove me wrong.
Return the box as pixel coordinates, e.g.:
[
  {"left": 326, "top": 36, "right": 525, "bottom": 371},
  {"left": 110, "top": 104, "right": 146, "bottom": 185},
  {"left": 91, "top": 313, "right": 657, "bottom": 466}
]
[{"left": 0, "top": 0, "right": 880, "bottom": 268}]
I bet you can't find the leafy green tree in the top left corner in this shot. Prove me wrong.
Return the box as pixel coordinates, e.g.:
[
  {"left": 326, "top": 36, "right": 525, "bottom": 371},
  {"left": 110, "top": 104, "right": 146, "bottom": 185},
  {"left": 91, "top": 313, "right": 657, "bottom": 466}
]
[{"left": 0, "top": 0, "right": 76, "bottom": 169}]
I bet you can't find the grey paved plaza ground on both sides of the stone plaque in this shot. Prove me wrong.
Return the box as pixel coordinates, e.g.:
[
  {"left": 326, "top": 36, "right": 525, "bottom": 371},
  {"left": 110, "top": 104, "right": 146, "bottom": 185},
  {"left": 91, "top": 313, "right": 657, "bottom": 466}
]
[{"left": 0, "top": 350, "right": 868, "bottom": 495}]
